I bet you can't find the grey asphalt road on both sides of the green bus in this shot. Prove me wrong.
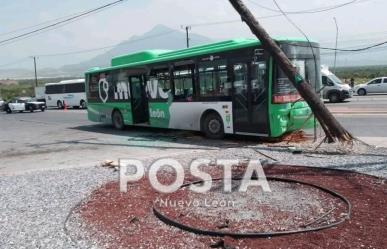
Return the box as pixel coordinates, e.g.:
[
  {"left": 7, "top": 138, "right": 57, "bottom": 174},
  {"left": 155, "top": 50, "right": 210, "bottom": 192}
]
[{"left": 0, "top": 95, "right": 387, "bottom": 175}]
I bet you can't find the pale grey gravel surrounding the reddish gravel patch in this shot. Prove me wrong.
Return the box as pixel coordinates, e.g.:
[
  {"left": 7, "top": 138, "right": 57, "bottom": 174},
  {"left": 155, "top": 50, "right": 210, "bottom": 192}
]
[{"left": 0, "top": 142, "right": 387, "bottom": 249}]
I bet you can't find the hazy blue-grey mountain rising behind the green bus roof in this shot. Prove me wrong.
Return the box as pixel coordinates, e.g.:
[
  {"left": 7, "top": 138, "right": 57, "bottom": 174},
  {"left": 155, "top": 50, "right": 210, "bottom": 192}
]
[{"left": 0, "top": 25, "right": 212, "bottom": 79}]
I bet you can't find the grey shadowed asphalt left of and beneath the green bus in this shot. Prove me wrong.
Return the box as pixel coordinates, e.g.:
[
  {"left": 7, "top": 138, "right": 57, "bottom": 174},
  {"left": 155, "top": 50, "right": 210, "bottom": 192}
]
[{"left": 0, "top": 110, "right": 227, "bottom": 175}]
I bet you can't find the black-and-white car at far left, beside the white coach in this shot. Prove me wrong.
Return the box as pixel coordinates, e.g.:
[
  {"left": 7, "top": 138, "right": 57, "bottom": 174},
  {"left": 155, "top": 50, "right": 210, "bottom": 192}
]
[{"left": 4, "top": 97, "right": 46, "bottom": 113}]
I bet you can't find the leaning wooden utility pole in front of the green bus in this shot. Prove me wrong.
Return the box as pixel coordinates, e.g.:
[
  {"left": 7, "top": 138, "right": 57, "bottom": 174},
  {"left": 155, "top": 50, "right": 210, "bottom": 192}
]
[{"left": 229, "top": 0, "right": 353, "bottom": 143}]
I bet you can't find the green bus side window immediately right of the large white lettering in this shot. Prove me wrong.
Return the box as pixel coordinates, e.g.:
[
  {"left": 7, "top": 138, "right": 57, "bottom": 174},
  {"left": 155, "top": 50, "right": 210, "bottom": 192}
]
[{"left": 173, "top": 67, "right": 193, "bottom": 101}]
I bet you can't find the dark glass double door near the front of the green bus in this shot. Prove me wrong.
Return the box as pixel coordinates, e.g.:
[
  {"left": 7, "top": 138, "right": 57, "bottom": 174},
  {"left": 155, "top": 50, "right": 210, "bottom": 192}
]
[{"left": 233, "top": 61, "right": 269, "bottom": 137}]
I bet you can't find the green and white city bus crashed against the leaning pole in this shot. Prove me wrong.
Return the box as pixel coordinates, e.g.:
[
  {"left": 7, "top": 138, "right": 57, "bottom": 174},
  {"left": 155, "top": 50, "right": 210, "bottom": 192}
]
[{"left": 86, "top": 38, "right": 321, "bottom": 138}]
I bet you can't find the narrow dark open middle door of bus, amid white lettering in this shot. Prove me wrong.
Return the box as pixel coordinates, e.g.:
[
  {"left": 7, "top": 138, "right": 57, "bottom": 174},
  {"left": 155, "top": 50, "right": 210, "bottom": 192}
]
[{"left": 129, "top": 75, "right": 149, "bottom": 124}]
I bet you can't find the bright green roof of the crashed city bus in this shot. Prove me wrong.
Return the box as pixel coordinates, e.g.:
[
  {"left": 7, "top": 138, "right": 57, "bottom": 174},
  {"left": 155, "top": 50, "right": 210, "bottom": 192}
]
[{"left": 86, "top": 37, "right": 315, "bottom": 74}]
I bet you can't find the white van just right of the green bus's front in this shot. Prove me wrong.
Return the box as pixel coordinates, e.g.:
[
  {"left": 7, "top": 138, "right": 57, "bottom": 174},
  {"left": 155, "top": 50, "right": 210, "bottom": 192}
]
[{"left": 321, "top": 66, "right": 352, "bottom": 103}]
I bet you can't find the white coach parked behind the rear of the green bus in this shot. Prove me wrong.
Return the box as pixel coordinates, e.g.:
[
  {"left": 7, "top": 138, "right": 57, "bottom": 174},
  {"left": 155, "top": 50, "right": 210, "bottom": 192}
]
[{"left": 45, "top": 79, "right": 87, "bottom": 109}]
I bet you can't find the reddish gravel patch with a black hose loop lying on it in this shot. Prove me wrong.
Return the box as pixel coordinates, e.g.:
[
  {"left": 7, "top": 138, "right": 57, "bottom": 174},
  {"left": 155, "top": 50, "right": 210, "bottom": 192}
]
[{"left": 75, "top": 165, "right": 387, "bottom": 249}]
